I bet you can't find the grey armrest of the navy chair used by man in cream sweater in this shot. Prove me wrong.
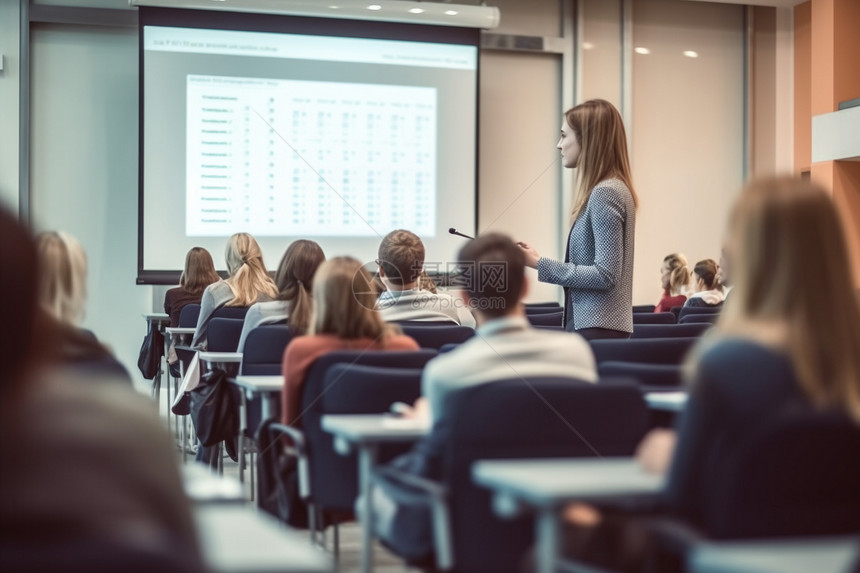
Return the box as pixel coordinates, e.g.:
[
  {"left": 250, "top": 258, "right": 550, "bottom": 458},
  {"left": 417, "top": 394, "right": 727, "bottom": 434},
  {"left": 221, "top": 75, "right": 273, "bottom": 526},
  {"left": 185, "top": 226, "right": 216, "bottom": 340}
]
[{"left": 376, "top": 467, "right": 454, "bottom": 571}]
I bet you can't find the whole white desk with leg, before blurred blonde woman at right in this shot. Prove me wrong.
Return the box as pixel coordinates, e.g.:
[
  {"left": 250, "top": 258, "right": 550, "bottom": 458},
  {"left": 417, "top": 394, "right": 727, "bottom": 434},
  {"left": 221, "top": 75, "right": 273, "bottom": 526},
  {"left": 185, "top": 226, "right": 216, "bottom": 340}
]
[{"left": 472, "top": 458, "right": 664, "bottom": 573}]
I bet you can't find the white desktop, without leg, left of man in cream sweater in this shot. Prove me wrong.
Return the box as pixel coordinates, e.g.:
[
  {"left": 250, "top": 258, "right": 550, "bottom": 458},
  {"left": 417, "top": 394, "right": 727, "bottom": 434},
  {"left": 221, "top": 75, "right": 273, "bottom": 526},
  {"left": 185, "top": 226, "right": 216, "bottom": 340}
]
[{"left": 322, "top": 414, "right": 430, "bottom": 444}]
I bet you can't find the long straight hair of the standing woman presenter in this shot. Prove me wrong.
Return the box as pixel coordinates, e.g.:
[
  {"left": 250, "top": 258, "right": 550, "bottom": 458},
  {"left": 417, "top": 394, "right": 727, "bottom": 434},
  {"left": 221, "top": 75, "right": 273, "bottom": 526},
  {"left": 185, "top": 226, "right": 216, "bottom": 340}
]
[{"left": 564, "top": 99, "right": 639, "bottom": 222}]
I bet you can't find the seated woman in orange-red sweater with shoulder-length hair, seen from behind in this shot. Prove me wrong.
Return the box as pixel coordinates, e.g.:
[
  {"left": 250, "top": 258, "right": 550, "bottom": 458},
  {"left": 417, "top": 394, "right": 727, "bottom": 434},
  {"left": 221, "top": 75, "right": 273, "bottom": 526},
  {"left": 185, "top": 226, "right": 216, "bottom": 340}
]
[{"left": 281, "top": 257, "right": 418, "bottom": 425}]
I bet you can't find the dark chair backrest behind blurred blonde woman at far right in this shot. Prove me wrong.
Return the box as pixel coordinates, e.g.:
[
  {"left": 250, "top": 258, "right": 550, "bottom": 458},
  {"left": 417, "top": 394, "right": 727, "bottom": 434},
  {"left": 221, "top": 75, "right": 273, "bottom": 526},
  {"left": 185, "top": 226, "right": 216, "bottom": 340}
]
[{"left": 705, "top": 412, "right": 860, "bottom": 538}]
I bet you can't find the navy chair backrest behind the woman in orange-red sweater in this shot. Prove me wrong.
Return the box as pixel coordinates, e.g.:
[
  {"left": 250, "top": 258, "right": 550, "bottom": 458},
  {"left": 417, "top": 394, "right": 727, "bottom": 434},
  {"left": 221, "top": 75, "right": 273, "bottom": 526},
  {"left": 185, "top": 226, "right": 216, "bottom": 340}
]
[{"left": 301, "top": 349, "right": 437, "bottom": 511}]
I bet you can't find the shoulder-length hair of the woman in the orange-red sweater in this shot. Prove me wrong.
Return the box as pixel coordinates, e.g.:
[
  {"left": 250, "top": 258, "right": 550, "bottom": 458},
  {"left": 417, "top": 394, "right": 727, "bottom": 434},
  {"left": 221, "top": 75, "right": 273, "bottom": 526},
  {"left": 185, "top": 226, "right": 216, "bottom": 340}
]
[{"left": 310, "top": 257, "right": 399, "bottom": 340}]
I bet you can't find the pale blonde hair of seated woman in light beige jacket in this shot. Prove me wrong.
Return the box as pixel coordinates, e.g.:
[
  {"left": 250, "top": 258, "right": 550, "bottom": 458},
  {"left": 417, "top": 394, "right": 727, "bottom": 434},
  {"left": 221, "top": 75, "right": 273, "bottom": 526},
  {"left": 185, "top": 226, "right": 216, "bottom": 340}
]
[{"left": 224, "top": 233, "right": 278, "bottom": 306}]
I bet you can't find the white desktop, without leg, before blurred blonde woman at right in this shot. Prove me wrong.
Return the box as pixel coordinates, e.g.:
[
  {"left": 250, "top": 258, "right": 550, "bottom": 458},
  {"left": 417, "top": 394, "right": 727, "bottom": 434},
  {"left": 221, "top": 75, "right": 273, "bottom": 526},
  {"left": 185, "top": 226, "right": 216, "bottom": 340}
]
[{"left": 472, "top": 458, "right": 664, "bottom": 507}]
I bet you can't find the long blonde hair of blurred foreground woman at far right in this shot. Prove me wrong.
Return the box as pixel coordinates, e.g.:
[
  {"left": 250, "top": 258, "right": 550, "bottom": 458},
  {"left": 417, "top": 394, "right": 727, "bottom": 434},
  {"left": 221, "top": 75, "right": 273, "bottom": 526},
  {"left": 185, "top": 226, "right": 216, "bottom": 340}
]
[{"left": 718, "top": 177, "right": 860, "bottom": 421}]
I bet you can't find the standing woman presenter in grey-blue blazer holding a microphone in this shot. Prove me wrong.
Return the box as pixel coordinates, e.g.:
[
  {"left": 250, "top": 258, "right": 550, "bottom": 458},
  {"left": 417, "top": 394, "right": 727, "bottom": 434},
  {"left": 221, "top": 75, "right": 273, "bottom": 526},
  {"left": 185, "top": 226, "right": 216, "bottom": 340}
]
[{"left": 520, "top": 99, "right": 636, "bottom": 339}]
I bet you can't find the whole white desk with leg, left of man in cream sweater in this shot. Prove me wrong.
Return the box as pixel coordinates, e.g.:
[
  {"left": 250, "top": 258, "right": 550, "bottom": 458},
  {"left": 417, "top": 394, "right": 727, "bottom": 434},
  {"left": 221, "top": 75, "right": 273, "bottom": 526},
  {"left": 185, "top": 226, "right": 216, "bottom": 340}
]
[{"left": 321, "top": 414, "right": 430, "bottom": 573}]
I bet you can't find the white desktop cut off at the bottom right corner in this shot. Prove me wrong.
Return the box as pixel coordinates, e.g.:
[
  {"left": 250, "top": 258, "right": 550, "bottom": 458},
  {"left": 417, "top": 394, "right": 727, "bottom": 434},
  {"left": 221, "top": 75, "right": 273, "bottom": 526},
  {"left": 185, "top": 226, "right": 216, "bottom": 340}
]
[{"left": 690, "top": 537, "right": 860, "bottom": 573}]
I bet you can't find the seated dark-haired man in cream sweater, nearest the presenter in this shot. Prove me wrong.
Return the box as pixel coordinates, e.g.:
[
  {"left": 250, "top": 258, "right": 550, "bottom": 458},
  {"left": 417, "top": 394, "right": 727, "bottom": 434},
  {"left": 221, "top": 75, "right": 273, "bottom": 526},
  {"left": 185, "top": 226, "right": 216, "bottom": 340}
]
[{"left": 370, "top": 233, "right": 597, "bottom": 555}]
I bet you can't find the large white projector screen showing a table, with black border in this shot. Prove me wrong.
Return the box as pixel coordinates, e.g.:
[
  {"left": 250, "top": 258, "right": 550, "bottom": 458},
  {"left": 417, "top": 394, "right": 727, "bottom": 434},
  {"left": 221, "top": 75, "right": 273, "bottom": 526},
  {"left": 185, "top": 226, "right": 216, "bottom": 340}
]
[{"left": 138, "top": 8, "right": 479, "bottom": 284}]
